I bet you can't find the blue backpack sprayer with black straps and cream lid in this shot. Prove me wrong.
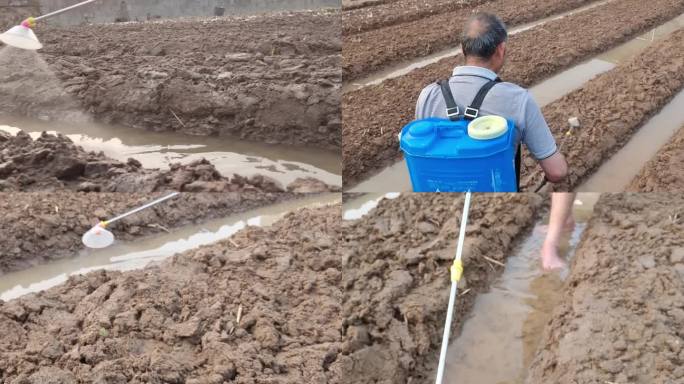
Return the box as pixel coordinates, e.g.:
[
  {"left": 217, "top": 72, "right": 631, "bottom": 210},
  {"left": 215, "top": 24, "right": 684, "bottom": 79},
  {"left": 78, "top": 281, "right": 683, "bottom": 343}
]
[{"left": 399, "top": 78, "right": 520, "bottom": 192}]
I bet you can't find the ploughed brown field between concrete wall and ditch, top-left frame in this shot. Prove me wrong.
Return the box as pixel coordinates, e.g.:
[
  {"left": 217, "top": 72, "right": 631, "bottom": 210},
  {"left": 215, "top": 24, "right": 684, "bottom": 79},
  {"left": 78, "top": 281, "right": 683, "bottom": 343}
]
[{"left": 0, "top": 11, "right": 341, "bottom": 149}]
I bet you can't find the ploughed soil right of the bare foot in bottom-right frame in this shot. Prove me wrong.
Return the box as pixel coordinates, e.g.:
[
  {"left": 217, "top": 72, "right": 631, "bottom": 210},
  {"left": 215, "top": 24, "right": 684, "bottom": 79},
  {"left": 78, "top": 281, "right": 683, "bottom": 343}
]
[{"left": 527, "top": 193, "right": 684, "bottom": 384}]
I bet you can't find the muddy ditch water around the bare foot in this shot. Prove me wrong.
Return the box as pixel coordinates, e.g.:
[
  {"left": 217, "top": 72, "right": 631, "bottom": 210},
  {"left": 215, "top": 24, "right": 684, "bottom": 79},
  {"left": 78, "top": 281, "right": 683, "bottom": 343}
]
[{"left": 445, "top": 194, "right": 598, "bottom": 384}]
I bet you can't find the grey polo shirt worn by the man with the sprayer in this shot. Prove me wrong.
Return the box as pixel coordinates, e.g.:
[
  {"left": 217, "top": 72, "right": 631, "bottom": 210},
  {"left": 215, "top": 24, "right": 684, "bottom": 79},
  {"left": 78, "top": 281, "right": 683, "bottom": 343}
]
[{"left": 416, "top": 66, "right": 557, "bottom": 160}]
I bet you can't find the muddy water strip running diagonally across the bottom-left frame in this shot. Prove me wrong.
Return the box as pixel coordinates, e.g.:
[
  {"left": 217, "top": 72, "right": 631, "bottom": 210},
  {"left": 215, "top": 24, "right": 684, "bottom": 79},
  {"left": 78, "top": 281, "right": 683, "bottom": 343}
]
[{"left": 0, "top": 194, "right": 340, "bottom": 300}]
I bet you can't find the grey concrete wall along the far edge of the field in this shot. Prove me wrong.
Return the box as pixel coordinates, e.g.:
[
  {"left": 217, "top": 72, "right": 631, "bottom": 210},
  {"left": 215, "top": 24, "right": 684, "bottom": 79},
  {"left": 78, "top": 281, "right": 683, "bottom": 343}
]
[{"left": 36, "top": 0, "right": 341, "bottom": 25}]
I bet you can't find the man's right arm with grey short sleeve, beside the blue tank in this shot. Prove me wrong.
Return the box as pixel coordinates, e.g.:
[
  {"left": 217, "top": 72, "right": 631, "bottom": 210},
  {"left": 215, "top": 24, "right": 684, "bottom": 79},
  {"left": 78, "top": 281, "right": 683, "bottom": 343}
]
[{"left": 522, "top": 92, "right": 568, "bottom": 183}]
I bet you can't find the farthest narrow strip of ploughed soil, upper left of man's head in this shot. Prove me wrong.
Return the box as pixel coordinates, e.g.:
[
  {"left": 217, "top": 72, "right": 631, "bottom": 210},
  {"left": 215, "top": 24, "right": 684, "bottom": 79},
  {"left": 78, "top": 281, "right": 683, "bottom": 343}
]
[{"left": 342, "top": 0, "right": 492, "bottom": 37}]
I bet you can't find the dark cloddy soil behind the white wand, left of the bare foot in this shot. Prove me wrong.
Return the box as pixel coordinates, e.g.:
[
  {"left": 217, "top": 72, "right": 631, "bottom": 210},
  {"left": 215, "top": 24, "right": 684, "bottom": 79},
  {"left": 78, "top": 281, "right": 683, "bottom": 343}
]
[{"left": 335, "top": 194, "right": 541, "bottom": 384}]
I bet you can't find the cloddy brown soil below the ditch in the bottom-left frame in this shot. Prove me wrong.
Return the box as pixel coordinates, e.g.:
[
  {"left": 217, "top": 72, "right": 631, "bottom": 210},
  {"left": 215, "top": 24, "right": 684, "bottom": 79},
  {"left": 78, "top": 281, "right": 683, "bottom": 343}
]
[{"left": 0, "top": 205, "right": 342, "bottom": 384}]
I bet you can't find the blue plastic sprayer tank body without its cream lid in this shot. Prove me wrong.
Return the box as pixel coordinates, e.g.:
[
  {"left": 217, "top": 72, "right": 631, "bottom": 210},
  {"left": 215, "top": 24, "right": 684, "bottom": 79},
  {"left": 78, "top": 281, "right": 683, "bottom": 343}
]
[{"left": 399, "top": 118, "right": 517, "bottom": 192}]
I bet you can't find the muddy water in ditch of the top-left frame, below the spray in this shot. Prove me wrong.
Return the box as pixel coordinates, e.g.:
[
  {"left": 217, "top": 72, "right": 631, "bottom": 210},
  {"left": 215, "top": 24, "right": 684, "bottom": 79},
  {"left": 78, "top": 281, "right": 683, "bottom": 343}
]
[{"left": 0, "top": 116, "right": 342, "bottom": 189}]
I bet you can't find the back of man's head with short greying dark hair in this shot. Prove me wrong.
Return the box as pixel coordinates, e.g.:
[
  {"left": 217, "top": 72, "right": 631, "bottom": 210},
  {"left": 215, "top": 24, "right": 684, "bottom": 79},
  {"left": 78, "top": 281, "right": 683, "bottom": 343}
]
[{"left": 461, "top": 12, "right": 508, "bottom": 61}]
